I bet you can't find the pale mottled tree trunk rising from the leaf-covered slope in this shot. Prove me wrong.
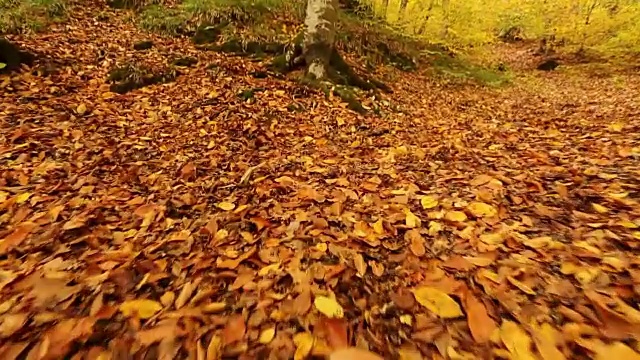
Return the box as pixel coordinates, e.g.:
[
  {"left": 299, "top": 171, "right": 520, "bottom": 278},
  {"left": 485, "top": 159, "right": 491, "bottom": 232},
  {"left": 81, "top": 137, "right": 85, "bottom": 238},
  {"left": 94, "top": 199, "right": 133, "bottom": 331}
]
[{"left": 302, "top": 0, "right": 338, "bottom": 80}]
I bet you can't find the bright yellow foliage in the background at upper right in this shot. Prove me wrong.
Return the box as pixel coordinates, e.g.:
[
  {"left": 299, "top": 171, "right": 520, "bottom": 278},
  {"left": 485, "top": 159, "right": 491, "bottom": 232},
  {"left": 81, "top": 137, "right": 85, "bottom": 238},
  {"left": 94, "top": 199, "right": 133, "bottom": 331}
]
[{"left": 363, "top": 0, "right": 640, "bottom": 55}]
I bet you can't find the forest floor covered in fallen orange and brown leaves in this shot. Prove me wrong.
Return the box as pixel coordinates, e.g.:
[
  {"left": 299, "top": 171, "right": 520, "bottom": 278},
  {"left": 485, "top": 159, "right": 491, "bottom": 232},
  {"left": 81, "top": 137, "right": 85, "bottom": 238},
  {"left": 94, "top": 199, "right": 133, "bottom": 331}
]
[{"left": 0, "top": 0, "right": 640, "bottom": 360}]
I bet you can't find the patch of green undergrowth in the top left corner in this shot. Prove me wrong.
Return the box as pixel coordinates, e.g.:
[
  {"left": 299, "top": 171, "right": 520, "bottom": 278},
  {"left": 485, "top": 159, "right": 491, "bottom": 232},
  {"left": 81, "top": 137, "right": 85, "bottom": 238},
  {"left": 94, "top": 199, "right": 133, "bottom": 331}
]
[{"left": 0, "top": 0, "right": 67, "bottom": 34}]
